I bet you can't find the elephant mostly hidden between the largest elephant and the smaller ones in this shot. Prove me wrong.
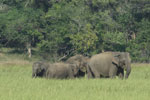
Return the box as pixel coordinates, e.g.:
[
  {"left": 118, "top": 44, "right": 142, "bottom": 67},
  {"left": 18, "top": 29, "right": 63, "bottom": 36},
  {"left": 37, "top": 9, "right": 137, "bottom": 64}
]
[{"left": 66, "top": 54, "right": 89, "bottom": 77}]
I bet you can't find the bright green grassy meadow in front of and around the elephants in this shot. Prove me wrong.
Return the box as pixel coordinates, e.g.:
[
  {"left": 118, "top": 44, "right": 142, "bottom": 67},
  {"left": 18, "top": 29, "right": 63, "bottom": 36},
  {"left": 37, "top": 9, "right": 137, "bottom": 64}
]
[{"left": 0, "top": 52, "right": 150, "bottom": 100}]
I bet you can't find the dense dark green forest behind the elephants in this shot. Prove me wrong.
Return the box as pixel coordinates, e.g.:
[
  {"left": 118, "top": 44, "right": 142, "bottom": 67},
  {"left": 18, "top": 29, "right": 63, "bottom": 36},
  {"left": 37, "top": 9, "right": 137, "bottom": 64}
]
[{"left": 0, "top": 0, "right": 150, "bottom": 62}]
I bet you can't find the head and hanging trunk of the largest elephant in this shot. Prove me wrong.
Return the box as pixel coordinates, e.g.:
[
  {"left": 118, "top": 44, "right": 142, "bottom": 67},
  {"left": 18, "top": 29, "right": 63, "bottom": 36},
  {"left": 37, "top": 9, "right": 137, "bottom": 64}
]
[{"left": 112, "top": 52, "right": 131, "bottom": 78}]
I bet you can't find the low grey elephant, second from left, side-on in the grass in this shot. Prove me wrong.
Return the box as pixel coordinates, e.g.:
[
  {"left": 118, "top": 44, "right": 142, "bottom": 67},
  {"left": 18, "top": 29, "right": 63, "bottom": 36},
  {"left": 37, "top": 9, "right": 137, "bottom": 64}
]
[{"left": 46, "top": 62, "right": 79, "bottom": 79}]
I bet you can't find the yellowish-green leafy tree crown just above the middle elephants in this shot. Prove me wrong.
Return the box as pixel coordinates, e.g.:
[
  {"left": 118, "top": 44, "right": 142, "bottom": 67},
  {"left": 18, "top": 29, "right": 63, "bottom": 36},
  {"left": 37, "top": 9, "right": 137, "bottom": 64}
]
[{"left": 70, "top": 24, "right": 98, "bottom": 55}]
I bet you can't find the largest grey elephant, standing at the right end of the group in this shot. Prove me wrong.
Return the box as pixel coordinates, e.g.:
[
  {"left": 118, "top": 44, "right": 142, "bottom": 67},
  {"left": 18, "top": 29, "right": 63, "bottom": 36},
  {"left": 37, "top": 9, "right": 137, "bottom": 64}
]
[{"left": 88, "top": 52, "right": 131, "bottom": 78}]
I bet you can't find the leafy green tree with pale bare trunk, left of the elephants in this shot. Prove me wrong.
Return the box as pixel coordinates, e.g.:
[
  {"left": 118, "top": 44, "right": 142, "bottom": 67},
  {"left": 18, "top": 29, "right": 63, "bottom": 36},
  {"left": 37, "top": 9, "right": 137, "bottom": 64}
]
[{"left": 1, "top": 8, "right": 42, "bottom": 57}]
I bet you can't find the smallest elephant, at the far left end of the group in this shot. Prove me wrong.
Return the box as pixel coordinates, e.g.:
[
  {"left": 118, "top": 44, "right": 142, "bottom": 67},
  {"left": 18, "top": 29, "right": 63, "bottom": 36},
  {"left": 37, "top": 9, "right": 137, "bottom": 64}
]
[{"left": 32, "top": 61, "right": 49, "bottom": 78}]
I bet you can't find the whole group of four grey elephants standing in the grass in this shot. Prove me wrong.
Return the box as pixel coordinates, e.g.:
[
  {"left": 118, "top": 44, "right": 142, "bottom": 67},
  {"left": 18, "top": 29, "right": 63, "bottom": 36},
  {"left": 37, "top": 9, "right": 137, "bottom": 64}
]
[{"left": 32, "top": 52, "right": 131, "bottom": 79}]
